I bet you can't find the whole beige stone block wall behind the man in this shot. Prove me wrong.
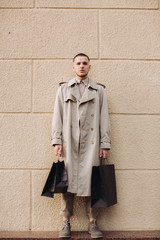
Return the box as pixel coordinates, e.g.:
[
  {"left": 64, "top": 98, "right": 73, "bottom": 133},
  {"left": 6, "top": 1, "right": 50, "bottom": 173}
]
[{"left": 0, "top": 0, "right": 160, "bottom": 231}]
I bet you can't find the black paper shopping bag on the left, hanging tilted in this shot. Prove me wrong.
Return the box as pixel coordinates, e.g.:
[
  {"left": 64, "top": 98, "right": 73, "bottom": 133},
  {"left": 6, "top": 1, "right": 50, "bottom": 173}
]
[{"left": 41, "top": 161, "right": 68, "bottom": 198}]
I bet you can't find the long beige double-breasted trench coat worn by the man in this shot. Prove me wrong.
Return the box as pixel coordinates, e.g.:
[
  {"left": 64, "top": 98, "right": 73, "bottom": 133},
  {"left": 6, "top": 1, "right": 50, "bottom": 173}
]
[{"left": 52, "top": 79, "right": 110, "bottom": 196}]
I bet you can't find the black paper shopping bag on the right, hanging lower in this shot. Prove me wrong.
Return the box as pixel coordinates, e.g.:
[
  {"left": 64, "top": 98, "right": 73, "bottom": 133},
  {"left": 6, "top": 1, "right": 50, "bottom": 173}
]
[{"left": 91, "top": 164, "right": 117, "bottom": 208}]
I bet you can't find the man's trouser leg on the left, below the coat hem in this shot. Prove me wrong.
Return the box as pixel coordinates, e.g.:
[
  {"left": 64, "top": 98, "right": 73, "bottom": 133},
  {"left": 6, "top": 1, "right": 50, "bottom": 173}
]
[{"left": 60, "top": 192, "right": 74, "bottom": 218}]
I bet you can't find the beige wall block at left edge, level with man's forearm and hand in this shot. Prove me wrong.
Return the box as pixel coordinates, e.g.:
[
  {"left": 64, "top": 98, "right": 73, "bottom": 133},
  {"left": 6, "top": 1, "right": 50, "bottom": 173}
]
[{"left": 0, "top": 114, "right": 54, "bottom": 169}]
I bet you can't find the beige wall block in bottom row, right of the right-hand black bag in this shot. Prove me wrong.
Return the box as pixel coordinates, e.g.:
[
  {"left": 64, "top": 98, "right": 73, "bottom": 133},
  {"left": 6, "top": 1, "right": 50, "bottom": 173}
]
[{"left": 98, "top": 170, "right": 160, "bottom": 231}]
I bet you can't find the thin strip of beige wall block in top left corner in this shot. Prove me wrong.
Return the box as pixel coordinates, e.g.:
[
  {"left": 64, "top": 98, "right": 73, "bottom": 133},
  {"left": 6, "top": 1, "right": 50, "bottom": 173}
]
[{"left": 0, "top": 0, "right": 34, "bottom": 8}]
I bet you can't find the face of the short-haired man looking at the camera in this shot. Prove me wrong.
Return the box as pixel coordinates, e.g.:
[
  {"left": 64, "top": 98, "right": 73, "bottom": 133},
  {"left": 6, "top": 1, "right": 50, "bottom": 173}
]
[{"left": 72, "top": 56, "right": 91, "bottom": 80}]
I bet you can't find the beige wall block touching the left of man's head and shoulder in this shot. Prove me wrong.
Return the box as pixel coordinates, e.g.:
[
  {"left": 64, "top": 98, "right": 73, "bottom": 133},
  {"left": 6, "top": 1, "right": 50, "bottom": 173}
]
[{"left": 33, "top": 60, "right": 74, "bottom": 112}]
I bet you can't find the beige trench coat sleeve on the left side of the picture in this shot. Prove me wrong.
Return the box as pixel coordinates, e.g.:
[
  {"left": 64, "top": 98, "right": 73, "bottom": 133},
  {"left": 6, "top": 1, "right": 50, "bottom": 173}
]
[{"left": 52, "top": 87, "right": 63, "bottom": 146}]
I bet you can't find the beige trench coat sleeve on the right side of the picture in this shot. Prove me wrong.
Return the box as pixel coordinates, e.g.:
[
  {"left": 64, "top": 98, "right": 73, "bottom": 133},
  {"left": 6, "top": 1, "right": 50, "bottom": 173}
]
[{"left": 100, "top": 87, "right": 111, "bottom": 149}]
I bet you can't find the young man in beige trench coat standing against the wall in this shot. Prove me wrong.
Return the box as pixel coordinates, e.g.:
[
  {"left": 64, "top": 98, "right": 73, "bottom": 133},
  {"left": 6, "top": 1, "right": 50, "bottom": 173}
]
[{"left": 52, "top": 53, "right": 110, "bottom": 238}]
